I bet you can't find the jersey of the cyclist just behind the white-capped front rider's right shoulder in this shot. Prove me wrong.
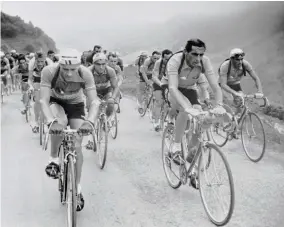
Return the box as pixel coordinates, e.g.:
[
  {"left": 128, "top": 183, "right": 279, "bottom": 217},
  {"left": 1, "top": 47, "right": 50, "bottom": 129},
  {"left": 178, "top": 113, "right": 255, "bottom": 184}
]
[{"left": 89, "top": 65, "right": 116, "bottom": 92}]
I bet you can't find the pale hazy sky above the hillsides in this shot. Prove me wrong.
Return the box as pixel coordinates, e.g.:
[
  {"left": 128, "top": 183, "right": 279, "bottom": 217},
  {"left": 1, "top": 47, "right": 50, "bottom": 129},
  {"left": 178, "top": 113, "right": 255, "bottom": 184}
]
[{"left": 1, "top": 1, "right": 258, "bottom": 51}]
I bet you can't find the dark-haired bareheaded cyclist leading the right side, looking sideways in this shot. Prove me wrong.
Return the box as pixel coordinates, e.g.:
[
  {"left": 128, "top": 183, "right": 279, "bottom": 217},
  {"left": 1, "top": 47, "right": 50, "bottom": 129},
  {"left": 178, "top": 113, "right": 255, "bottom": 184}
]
[{"left": 167, "top": 39, "right": 226, "bottom": 188}]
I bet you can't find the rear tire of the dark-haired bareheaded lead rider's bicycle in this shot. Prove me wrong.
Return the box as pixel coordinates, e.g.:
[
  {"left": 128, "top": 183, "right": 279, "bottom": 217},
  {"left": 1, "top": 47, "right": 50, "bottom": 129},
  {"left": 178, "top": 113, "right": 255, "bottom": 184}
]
[{"left": 162, "top": 124, "right": 182, "bottom": 189}]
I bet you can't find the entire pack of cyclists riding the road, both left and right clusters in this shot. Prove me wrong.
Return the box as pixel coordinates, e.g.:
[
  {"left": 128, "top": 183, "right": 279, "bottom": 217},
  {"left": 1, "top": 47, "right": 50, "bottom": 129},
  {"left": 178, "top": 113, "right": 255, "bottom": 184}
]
[{"left": 1, "top": 39, "right": 263, "bottom": 216}]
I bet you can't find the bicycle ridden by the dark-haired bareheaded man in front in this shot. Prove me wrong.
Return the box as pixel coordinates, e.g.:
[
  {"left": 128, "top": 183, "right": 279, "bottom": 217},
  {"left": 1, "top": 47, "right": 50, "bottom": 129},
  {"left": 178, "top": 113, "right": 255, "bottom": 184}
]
[{"left": 162, "top": 110, "right": 235, "bottom": 226}]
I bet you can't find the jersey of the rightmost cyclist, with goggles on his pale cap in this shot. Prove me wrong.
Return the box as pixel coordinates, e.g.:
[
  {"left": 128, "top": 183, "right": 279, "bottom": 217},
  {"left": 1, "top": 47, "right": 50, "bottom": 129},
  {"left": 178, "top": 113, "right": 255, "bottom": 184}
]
[{"left": 219, "top": 60, "right": 253, "bottom": 85}]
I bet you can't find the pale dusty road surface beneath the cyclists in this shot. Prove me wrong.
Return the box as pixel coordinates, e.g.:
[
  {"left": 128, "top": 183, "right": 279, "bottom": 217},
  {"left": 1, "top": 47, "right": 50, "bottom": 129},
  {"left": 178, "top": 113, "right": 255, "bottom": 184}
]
[{"left": 1, "top": 92, "right": 284, "bottom": 227}]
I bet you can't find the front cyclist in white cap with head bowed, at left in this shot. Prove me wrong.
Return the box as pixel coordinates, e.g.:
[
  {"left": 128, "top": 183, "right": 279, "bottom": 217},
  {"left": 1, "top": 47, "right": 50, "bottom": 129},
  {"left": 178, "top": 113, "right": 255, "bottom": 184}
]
[{"left": 40, "top": 51, "right": 100, "bottom": 211}]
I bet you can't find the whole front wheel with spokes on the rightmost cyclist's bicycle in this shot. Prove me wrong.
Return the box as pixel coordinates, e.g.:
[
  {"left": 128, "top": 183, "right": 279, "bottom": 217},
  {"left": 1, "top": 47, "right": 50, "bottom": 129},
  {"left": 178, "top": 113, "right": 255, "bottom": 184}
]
[{"left": 241, "top": 112, "right": 266, "bottom": 162}]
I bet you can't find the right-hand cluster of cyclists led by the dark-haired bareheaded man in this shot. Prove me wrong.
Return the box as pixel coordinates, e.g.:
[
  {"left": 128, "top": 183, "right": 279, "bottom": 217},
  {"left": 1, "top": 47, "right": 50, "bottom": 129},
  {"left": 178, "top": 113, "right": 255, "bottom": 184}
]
[{"left": 135, "top": 39, "right": 263, "bottom": 189}]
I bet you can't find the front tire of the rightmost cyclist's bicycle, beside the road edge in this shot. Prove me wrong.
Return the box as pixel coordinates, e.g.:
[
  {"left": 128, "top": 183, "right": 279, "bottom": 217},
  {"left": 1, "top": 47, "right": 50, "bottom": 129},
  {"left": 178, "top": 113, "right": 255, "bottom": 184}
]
[{"left": 241, "top": 112, "right": 266, "bottom": 162}]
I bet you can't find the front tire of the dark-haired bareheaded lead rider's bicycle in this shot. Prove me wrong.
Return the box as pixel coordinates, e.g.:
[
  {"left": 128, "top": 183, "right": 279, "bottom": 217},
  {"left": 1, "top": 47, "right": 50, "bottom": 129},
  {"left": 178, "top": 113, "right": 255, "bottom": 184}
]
[{"left": 198, "top": 143, "right": 235, "bottom": 226}]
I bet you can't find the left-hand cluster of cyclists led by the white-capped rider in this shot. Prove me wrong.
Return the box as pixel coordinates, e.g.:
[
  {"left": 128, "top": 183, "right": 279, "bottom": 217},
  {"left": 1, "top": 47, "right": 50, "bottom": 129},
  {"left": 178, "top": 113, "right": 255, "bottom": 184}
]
[{"left": 1, "top": 45, "right": 124, "bottom": 211}]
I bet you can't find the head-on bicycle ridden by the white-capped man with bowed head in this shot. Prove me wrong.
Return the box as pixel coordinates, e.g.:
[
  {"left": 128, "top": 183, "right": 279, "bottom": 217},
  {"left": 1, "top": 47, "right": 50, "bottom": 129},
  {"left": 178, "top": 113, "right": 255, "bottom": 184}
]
[{"left": 43, "top": 125, "right": 92, "bottom": 227}]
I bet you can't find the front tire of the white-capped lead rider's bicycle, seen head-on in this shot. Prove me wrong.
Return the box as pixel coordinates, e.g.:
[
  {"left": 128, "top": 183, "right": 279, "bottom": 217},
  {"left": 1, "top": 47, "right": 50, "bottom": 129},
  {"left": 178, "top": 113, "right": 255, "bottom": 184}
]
[{"left": 66, "top": 155, "right": 77, "bottom": 227}]
